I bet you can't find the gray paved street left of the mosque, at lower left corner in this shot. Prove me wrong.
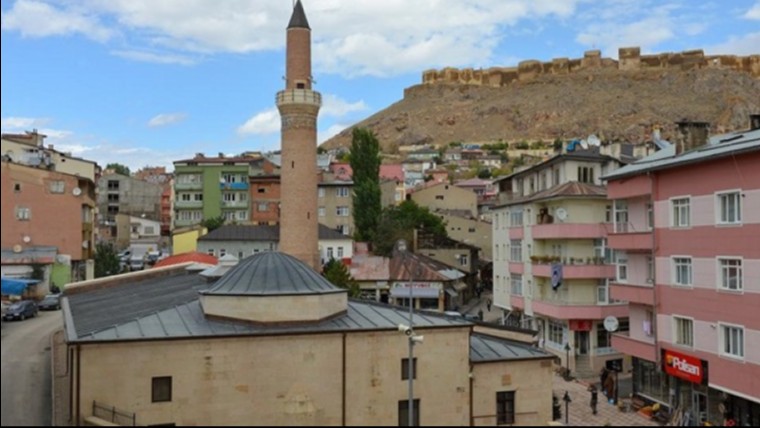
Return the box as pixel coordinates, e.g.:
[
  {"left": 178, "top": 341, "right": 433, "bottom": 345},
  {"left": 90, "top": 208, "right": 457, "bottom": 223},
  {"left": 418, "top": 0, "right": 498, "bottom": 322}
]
[{"left": 0, "top": 311, "right": 63, "bottom": 426}]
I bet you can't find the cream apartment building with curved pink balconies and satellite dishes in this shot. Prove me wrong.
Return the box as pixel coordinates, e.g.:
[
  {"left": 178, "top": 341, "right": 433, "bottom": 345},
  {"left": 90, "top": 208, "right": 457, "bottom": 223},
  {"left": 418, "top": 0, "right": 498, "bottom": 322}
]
[{"left": 492, "top": 147, "right": 628, "bottom": 376}]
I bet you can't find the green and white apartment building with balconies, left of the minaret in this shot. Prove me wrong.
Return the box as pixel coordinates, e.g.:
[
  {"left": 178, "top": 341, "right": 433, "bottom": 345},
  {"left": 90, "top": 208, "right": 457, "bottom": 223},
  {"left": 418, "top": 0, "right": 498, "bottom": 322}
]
[{"left": 174, "top": 153, "right": 254, "bottom": 227}]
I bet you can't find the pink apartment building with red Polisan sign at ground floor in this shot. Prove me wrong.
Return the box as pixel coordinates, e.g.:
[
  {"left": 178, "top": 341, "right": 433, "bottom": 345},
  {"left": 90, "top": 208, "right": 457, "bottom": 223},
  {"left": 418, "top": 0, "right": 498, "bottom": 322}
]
[{"left": 605, "top": 115, "right": 760, "bottom": 426}]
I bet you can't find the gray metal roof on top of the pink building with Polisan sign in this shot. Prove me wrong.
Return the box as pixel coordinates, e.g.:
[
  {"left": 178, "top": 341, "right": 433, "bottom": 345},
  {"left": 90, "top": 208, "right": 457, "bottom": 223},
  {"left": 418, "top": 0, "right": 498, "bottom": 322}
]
[{"left": 602, "top": 129, "right": 760, "bottom": 180}]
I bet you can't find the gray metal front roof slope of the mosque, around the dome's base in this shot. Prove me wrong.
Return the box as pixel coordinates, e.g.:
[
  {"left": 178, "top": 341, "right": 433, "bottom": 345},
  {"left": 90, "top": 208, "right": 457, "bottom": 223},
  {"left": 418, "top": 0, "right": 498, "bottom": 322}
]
[{"left": 64, "top": 296, "right": 472, "bottom": 342}]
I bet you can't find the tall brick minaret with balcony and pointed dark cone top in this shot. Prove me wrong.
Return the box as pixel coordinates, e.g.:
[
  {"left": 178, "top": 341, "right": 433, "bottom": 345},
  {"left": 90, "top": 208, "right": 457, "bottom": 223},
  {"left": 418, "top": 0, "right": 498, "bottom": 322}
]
[{"left": 277, "top": 0, "right": 322, "bottom": 270}]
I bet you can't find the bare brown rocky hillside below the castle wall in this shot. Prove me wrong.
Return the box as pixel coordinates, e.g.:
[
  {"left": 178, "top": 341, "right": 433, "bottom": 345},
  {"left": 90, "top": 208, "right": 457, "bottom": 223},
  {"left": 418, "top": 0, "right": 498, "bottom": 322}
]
[{"left": 322, "top": 69, "right": 760, "bottom": 152}]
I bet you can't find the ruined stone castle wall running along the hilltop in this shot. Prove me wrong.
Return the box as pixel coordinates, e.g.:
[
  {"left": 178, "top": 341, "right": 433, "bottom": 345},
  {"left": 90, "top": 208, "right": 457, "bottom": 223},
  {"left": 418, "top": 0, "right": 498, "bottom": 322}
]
[{"left": 422, "top": 47, "right": 760, "bottom": 87}]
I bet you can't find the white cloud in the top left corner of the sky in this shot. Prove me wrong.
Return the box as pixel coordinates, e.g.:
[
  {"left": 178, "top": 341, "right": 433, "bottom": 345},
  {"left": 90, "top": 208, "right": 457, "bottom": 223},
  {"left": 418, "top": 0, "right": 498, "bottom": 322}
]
[{"left": 2, "top": 0, "right": 114, "bottom": 42}]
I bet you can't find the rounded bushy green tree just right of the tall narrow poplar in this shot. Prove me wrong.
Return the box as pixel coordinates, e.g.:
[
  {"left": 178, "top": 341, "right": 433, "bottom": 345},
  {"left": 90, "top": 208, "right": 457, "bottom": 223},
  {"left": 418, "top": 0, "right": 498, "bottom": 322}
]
[{"left": 372, "top": 200, "right": 448, "bottom": 256}]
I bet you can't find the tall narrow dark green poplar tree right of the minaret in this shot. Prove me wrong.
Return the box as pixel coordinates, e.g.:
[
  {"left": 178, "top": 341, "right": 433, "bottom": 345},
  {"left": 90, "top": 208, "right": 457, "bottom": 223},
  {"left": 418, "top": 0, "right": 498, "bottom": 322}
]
[{"left": 350, "top": 128, "right": 382, "bottom": 241}]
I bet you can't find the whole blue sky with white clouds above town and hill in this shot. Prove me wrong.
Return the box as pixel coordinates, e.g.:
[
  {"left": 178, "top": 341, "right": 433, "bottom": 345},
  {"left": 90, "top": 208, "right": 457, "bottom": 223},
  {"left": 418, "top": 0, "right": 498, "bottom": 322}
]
[{"left": 0, "top": 0, "right": 760, "bottom": 171}]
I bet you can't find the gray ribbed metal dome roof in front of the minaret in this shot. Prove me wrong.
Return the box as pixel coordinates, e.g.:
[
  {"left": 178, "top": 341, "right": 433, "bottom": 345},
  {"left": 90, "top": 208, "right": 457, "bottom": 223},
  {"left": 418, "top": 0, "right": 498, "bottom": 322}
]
[{"left": 203, "top": 252, "right": 346, "bottom": 296}]
